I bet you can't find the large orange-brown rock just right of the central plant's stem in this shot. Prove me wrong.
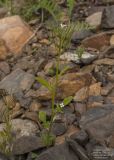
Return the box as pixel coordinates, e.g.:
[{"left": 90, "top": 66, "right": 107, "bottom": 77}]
[{"left": 59, "top": 73, "right": 92, "bottom": 98}]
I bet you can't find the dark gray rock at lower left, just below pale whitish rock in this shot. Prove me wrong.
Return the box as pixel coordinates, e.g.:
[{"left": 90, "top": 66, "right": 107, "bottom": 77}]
[{"left": 13, "top": 136, "right": 45, "bottom": 155}]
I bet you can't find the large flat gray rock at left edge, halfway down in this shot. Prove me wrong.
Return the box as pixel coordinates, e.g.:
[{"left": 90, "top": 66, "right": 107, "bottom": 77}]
[{"left": 0, "top": 69, "right": 34, "bottom": 94}]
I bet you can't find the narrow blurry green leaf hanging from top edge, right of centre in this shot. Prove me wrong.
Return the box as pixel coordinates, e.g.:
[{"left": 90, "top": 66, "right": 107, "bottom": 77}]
[{"left": 67, "top": 0, "right": 75, "bottom": 19}]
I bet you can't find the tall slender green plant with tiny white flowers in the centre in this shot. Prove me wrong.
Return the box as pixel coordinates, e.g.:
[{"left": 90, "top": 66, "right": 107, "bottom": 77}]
[{"left": 36, "top": 24, "right": 75, "bottom": 146}]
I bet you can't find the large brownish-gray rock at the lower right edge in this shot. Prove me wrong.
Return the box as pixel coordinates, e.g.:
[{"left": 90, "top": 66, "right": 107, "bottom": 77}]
[{"left": 79, "top": 105, "right": 114, "bottom": 142}]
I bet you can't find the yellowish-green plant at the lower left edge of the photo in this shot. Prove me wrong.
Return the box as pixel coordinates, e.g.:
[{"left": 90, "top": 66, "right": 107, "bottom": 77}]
[{"left": 0, "top": 95, "right": 14, "bottom": 156}]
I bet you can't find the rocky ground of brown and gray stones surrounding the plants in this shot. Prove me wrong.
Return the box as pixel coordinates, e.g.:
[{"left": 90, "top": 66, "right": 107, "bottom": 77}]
[{"left": 0, "top": 0, "right": 114, "bottom": 160}]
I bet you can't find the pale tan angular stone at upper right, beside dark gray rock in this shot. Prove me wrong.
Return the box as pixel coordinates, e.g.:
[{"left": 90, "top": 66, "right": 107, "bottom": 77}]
[{"left": 86, "top": 12, "right": 102, "bottom": 28}]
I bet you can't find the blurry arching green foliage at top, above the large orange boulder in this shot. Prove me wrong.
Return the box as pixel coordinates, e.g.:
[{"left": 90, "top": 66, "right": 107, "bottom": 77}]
[{"left": 21, "top": 0, "right": 60, "bottom": 22}]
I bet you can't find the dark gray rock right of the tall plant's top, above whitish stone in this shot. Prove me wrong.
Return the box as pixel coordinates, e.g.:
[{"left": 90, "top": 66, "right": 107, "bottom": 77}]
[{"left": 72, "top": 30, "right": 93, "bottom": 43}]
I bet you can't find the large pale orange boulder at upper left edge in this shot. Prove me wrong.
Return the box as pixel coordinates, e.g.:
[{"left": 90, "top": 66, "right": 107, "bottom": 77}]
[{"left": 0, "top": 16, "right": 33, "bottom": 59}]
